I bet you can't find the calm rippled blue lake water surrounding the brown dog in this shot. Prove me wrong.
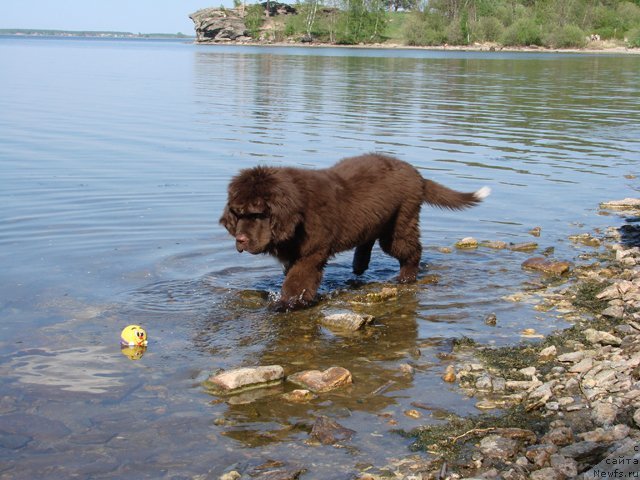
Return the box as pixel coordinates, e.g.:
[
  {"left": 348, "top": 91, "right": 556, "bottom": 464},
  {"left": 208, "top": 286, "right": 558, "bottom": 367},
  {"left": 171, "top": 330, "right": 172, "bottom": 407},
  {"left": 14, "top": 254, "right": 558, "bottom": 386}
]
[{"left": 0, "top": 37, "right": 640, "bottom": 480}]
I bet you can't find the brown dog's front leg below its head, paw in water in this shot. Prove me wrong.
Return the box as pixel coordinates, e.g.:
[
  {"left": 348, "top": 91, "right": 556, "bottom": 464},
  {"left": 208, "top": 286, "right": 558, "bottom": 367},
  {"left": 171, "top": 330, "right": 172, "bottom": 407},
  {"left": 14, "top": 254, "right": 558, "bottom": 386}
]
[{"left": 276, "top": 253, "right": 328, "bottom": 310}]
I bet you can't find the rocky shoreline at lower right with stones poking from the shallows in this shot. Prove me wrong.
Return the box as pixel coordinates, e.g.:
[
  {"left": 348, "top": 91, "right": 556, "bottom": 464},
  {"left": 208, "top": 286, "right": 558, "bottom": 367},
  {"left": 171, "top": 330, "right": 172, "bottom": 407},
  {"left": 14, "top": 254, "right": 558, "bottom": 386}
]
[{"left": 208, "top": 199, "right": 640, "bottom": 480}]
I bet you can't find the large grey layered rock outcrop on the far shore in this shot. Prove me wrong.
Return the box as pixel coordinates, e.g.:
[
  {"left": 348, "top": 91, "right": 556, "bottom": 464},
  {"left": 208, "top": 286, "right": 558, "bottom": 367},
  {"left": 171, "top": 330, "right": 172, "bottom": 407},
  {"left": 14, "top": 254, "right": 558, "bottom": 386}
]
[{"left": 189, "top": 8, "right": 251, "bottom": 43}]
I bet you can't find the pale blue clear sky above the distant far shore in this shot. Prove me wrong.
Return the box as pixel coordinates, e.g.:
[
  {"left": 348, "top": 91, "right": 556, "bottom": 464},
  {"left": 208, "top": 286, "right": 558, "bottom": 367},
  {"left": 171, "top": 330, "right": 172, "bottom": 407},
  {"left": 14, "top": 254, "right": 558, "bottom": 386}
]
[{"left": 0, "top": 0, "right": 233, "bottom": 35}]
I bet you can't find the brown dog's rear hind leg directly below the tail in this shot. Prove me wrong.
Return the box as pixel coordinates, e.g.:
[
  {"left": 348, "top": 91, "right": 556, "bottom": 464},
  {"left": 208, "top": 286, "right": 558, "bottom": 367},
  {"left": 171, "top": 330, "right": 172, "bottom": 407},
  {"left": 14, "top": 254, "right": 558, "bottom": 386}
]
[{"left": 380, "top": 205, "right": 422, "bottom": 283}]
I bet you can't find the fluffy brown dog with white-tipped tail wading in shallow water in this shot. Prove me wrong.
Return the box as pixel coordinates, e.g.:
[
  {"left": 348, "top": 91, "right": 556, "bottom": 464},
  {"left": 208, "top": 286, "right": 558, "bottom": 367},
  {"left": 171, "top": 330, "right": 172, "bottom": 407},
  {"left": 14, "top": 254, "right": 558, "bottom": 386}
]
[{"left": 220, "top": 154, "right": 490, "bottom": 309}]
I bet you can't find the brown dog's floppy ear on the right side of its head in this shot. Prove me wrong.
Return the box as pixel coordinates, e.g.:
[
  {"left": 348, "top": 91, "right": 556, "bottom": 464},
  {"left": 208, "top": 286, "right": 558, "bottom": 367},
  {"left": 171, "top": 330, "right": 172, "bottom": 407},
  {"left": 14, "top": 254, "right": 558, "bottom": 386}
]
[{"left": 268, "top": 172, "right": 304, "bottom": 243}]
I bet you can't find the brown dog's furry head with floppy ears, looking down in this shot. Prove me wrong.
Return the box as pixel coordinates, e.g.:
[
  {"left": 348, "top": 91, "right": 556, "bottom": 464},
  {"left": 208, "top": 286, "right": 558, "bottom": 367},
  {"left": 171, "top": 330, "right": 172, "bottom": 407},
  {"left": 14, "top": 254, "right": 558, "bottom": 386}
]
[{"left": 220, "top": 167, "right": 303, "bottom": 254}]
